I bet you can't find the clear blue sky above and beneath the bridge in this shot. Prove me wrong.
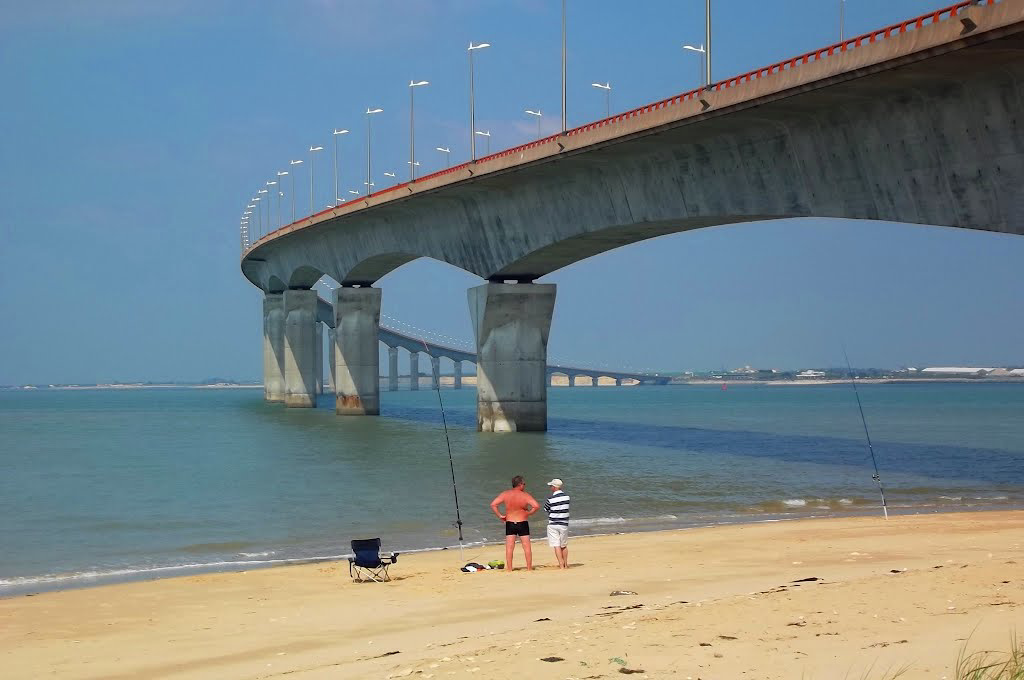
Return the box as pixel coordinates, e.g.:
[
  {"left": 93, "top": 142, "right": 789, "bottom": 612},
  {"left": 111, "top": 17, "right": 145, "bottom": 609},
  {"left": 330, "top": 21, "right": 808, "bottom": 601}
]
[{"left": 0, "top": 0, "right": 1024, "bottom": 384}]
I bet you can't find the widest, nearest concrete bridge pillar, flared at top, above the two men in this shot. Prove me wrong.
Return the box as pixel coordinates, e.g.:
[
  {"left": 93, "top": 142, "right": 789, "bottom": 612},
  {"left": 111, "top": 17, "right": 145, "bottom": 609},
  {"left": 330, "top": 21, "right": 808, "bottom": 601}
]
[{"left": 469, "top": 284, "right": 555, "bottom": 432}]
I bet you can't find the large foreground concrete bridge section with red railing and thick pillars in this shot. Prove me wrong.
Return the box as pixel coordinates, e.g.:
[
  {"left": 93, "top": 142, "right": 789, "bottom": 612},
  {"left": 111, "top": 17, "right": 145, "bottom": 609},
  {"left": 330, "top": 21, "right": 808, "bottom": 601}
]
[{"left": 242, "top": 0, "right": 1024, "bottom": 431}]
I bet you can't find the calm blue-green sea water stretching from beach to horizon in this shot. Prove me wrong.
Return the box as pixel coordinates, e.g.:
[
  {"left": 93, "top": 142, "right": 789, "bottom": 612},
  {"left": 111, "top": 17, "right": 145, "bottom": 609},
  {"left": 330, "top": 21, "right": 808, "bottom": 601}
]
[{"left": 0, "top": 384, "right": 1024, "bottom": 596}]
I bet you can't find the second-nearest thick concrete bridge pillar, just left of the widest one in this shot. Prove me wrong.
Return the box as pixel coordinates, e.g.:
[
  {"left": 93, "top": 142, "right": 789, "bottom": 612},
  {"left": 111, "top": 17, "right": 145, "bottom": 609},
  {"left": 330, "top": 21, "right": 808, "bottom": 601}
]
[{"left": 332, "top": 287, "right": 381, "bottom": 416}]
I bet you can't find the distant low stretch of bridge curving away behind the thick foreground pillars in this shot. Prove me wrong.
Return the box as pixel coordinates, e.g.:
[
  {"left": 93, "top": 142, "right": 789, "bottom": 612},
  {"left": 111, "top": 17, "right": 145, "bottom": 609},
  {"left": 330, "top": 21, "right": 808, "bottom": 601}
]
[{"left": 303, "top": 298, "right": 671, "bottom": 391}]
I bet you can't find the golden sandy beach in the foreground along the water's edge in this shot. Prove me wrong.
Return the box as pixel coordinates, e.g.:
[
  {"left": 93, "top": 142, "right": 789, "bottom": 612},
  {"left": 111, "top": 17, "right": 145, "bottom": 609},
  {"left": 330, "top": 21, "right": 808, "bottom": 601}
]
[{"left": 0, "top": 512, "right": 1024, "bottom": 680}]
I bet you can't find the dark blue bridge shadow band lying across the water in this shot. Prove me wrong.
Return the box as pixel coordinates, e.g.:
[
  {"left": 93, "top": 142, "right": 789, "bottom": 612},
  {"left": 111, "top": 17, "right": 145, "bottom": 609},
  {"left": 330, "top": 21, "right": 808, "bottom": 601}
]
[{"left": 386, "top": 407, "right": 1024, "bottom": 487}]
